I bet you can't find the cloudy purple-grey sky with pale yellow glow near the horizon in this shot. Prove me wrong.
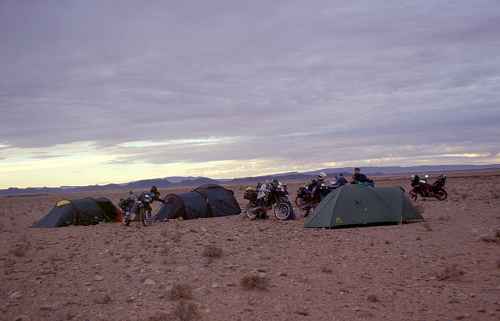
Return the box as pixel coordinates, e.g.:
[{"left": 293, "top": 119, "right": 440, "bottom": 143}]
[{"left": 0, "top": 0, "right": 500, "bottom": 188}]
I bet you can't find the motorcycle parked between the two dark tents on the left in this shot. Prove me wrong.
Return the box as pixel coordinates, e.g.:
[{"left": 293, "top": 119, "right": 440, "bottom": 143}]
[{"left": 118, "top": 192, "right": 153, "bottom": 226}]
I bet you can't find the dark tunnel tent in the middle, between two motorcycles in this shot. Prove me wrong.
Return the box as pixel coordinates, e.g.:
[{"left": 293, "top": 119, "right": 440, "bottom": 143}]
[{"left": 155, "top": 184, "right": 241, "bottom": 221}]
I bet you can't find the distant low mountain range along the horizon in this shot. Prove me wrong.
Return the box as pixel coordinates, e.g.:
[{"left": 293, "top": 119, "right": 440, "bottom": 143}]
[{"left": 0, "top": 164, "right": 500, "bottom": 196}]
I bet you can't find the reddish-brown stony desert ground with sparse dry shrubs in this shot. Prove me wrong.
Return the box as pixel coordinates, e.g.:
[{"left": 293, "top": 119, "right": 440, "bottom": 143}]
[{"left": 0, "top": 172, "right": 500, "bottom": 321}]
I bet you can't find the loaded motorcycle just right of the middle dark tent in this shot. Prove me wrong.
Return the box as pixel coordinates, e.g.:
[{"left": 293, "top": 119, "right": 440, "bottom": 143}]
[{"left": 243, "top": 183, "right": 294, "bottom": 221}]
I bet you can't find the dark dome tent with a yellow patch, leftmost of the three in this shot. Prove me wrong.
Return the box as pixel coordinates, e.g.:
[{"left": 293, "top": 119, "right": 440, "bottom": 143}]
[{"left": 33, "top": 197, "right": 121, "bottom": 227}]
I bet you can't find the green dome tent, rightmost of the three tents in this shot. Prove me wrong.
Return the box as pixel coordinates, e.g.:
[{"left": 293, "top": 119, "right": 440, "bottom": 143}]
[{"left": 304, "top": 185, "right": 423, "bottom": 228}]
